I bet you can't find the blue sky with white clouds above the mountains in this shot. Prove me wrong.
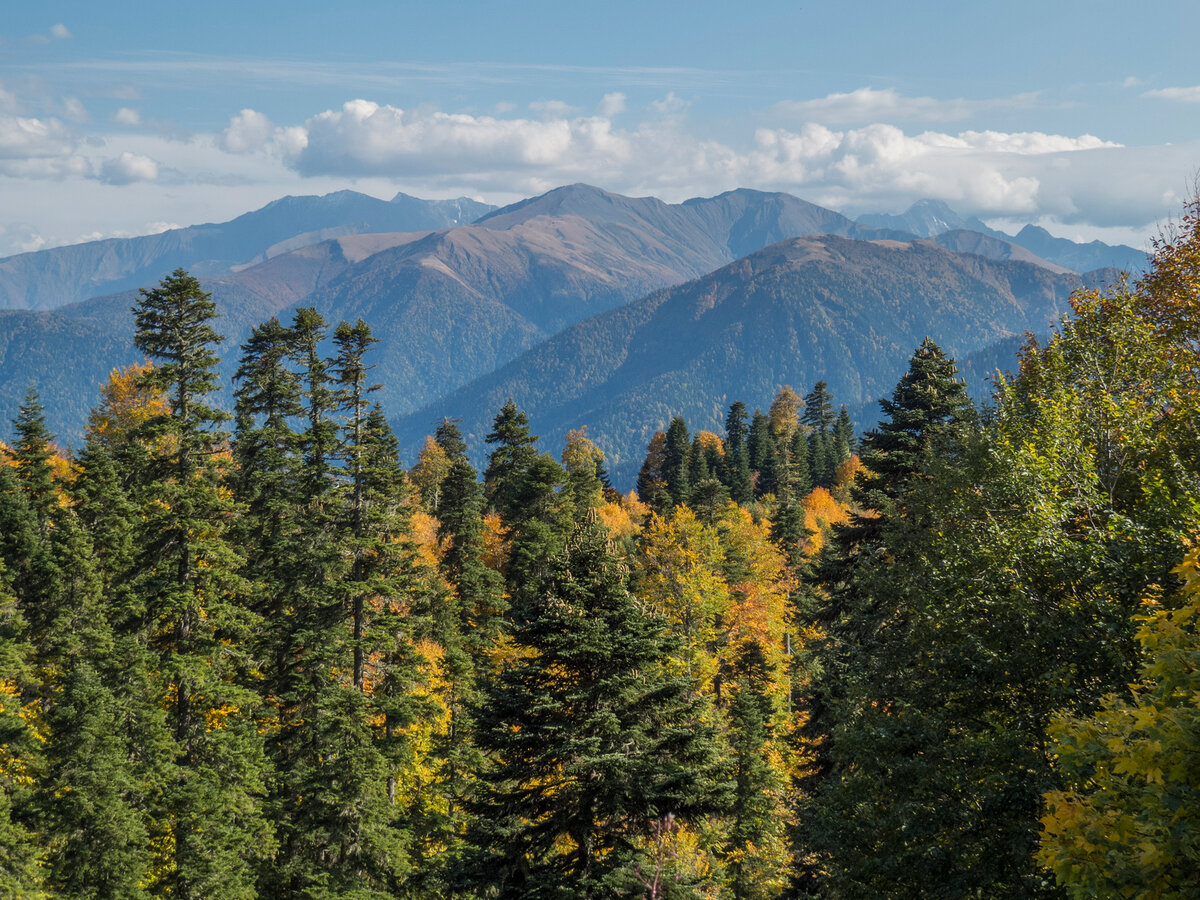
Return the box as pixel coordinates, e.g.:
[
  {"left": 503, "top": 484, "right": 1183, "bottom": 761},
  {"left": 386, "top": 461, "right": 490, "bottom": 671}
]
[{"left": 0, "top": 0, "right": 1200, "bottom": 256}]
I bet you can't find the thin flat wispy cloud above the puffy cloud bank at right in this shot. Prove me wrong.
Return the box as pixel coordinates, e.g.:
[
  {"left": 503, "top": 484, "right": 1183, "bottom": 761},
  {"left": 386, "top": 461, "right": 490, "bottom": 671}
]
[{"left": 775, "top": 88, "right": 1037, "bottom": 125}]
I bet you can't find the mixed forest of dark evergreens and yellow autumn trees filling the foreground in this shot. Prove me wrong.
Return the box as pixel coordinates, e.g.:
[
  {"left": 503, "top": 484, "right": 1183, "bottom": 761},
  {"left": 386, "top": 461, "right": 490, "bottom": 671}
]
[{"left": 0, "top": 204, "right": 1200, "bottom": 900}]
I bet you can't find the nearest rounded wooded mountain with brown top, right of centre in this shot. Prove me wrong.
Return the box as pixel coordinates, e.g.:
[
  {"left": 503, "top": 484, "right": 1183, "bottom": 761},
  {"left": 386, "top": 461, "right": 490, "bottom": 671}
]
[{"left": 396, "top": 235, "right": 1081, "bottom": 485}]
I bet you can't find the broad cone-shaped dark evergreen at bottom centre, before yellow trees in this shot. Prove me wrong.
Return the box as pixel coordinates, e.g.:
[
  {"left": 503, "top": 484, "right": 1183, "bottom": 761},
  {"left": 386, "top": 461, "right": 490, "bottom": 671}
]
[{"left": 472, "top": 511, "right": 721, "bottom": 898}]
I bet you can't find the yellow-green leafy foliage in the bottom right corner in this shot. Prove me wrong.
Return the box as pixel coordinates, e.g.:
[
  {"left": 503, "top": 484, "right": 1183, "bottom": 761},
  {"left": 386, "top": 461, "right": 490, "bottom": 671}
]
[{"left": 1039, "top": 547, "right": 1200, "bottom": 899}]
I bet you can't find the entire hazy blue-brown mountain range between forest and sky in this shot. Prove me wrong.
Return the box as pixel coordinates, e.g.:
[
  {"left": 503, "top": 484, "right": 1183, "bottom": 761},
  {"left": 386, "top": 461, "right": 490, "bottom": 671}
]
[{"left": 0, "top": 185, "right": 1146, "bottom": 486}]
